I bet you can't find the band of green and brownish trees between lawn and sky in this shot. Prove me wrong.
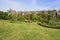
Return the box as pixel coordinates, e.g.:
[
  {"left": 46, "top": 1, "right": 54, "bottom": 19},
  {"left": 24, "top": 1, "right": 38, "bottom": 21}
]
[{"left": 0, "top": 10, "right": 60, "bottom": 23}]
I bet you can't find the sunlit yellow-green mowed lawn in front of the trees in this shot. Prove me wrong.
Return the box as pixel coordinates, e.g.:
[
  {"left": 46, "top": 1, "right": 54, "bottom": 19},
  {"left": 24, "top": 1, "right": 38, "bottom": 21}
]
[{"left": 0, "top": 20, "right": 60, "bottom": 40}]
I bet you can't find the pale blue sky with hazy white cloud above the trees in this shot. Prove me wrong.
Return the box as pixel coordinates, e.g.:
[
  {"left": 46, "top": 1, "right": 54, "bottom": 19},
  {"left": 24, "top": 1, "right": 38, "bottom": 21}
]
[{"left": 0, "top": 0, "right": 60, "bottom": 11}]
